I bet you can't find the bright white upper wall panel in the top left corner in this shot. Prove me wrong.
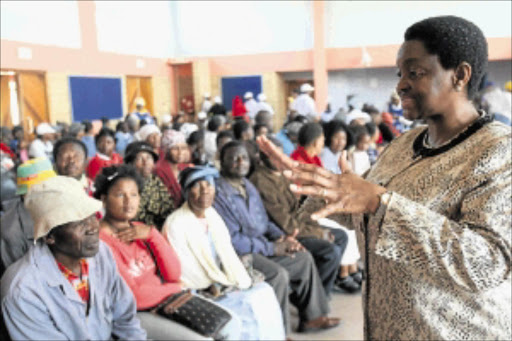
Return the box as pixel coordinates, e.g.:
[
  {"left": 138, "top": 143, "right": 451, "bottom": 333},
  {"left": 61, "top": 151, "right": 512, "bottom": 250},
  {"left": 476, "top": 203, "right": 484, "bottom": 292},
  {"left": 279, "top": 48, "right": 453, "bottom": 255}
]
[{"left": 0, "top": 1, "right": 82, "bottom": 48}]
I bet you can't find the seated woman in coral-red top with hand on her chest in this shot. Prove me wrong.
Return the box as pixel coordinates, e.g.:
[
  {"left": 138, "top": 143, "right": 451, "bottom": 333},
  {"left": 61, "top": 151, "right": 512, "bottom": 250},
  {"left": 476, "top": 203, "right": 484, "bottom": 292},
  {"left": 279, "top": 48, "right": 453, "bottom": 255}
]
[{"left": 94, "top": 165, "right": 240, "bottom": 340}]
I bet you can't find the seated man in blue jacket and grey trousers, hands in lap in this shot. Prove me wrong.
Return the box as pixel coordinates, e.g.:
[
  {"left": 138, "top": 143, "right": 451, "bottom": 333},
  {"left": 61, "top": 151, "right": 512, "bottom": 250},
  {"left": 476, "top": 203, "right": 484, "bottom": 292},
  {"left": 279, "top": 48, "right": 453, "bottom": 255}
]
[{"left": 214, "top": 141, "right": 340, "bottom": 332}]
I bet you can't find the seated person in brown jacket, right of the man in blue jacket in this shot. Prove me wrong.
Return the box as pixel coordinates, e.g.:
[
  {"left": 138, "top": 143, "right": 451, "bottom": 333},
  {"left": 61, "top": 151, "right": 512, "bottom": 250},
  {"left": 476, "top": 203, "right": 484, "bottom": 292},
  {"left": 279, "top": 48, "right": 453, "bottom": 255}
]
[{"left": 250, "top": 136, "right": 348, "bottom": 295}]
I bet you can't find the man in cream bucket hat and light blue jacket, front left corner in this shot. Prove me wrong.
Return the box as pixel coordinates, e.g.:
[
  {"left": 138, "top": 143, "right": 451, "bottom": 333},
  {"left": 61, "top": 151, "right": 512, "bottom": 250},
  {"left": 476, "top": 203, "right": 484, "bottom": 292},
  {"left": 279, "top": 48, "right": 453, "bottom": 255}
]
[{"left": 1, "top": 176, "right": 146, "bottom": 340}]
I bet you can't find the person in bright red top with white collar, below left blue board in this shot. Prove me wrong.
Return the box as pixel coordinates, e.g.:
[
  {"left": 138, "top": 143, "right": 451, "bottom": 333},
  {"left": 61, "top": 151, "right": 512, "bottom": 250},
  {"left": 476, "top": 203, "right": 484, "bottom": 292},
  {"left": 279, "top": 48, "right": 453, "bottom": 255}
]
[{"left": 86, "top": 128, "right": 123, "bottom": 180}]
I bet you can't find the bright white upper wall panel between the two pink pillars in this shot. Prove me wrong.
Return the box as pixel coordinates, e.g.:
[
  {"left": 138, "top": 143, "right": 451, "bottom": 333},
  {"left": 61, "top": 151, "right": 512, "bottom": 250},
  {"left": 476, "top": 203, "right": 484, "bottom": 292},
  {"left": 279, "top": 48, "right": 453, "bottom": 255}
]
[{"left": 171, "top": 1, "right": 313, "bottom": 57}]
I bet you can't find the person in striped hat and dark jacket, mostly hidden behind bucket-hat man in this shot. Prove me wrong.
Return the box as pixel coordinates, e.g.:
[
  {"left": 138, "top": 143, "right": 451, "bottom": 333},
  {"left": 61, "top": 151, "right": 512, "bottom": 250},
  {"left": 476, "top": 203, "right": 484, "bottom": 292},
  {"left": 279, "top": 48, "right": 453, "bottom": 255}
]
[{"left": 0, "top": 157, "right": 56, "bottom": 270}]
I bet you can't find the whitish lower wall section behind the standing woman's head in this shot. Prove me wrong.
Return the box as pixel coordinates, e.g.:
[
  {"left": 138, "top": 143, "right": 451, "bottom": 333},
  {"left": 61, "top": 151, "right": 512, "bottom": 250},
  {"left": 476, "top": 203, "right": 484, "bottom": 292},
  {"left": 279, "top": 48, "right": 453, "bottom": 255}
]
[{"left": 328, "top": 61, "right": 512, "bottom": 111}]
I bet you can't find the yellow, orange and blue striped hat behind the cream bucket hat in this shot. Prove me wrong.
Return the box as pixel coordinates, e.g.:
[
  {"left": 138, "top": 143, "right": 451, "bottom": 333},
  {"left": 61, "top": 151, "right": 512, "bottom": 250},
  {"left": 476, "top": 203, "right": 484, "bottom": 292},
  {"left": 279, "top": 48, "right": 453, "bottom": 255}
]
[{"left": 16, "top": 157, "right": 57, "bottom": 195}]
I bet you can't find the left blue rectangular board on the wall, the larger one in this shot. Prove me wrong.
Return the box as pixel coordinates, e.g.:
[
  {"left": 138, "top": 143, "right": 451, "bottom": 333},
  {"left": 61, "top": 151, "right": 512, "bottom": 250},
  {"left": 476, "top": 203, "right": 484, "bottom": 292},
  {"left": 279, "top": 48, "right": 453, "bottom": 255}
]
[{"left": 69, "top": 76, "right": 123, "bottom": 122}]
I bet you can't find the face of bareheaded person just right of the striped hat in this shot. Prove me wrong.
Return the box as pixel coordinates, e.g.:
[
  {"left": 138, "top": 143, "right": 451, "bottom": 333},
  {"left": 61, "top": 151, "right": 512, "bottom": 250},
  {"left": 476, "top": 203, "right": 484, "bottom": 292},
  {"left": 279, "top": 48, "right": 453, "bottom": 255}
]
[{"left": 55, "top": 143, "right": 87, "bottom": 180}]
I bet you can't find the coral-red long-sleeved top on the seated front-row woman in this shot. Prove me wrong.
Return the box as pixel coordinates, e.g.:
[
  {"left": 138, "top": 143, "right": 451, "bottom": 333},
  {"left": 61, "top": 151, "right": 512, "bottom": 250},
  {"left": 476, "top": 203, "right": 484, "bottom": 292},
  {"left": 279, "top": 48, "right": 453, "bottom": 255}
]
[{"left": 100, "top": 224, "right": 181, "bottom": 310}]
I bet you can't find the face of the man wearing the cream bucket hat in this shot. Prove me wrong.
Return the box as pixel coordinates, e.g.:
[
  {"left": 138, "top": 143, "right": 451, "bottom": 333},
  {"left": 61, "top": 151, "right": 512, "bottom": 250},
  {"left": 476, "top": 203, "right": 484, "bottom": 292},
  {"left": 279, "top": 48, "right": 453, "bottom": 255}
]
[{"left": 46, "top": 214, "right": 100, "bottom": 260}]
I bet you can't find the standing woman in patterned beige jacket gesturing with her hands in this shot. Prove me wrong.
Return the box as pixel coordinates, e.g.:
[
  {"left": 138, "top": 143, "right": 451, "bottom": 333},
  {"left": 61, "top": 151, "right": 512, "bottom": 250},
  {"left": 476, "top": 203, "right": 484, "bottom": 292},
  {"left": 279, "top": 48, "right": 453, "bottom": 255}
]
[{"left": 259, "top": 16, "right": 512, "bottom": 340}]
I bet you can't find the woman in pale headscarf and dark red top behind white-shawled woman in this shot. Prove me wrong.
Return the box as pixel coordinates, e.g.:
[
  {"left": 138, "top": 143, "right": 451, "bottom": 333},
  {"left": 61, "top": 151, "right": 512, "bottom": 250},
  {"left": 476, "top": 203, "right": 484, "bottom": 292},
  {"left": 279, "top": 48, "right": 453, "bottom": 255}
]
[{"left": 154, "top": 129, "right": 192, "bottom": 207}]
